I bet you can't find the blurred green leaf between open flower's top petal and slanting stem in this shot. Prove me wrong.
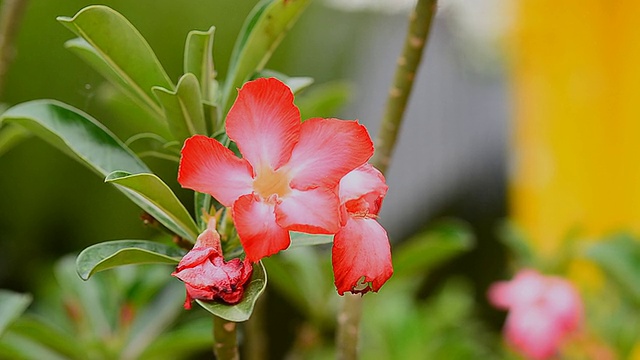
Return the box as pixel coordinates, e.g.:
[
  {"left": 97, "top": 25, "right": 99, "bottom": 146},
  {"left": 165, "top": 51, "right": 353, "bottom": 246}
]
[{"left": 296, "top": 82, "right": 352, "bottom": 121}]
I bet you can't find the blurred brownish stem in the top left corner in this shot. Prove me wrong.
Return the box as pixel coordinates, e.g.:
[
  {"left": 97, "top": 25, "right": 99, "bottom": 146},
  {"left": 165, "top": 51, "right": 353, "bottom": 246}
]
[{"left": 0, "top": 0, "right": 27, "bottom": 100}]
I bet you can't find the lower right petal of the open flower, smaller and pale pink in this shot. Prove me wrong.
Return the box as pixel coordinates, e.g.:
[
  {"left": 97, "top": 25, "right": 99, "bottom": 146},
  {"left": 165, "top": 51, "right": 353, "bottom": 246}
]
[{"left": 275, "top": 188, "right": 340, "bottom": 234}]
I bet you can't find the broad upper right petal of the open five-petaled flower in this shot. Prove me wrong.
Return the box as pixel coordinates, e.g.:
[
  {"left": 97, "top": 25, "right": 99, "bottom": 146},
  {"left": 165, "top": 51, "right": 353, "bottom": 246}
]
[{"left": 287, "top": 119, "right": 373, "bottom": 190}]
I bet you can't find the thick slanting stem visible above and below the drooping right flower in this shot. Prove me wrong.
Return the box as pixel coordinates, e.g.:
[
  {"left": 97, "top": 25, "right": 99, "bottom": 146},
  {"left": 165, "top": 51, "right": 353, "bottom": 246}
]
[{"left": 336, "top": 0, "right": 437, "bottom": 360}]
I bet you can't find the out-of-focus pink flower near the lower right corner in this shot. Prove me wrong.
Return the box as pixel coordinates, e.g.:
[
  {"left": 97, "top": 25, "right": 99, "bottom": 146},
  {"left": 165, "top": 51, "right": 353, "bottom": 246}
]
[{"left": 488, "top": 269, "right": 582, "bottom": 359}]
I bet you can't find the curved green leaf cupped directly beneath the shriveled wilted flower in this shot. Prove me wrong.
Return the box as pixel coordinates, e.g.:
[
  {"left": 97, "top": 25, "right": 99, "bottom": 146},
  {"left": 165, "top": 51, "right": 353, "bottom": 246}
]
[{"left": 196, "top": 262, "right": 267, "bottom": 322}]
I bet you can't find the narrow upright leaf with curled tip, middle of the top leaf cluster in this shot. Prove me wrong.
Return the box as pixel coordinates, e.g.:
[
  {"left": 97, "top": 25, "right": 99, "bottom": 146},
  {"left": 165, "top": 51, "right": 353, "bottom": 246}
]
[{"left": 184, "top": 26, "right": 216, "bottom": 103}]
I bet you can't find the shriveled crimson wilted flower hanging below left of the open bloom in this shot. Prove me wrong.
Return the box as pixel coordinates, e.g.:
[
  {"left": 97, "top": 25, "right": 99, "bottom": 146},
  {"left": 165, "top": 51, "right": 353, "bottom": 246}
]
[{"left": 171, "top": 218, "right": 253, "bottom": 310}]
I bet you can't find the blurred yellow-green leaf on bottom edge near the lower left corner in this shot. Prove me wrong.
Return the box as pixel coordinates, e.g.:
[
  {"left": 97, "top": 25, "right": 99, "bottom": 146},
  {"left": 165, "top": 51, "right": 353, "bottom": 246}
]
[{"left": 11, "top": 316, "right": 86, "bottom": 360}]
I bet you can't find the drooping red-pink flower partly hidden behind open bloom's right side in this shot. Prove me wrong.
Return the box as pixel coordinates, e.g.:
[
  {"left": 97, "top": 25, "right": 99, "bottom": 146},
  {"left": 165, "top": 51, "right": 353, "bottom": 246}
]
[{"left": 332, "top": 164, "right": 393, "bottom": 295}]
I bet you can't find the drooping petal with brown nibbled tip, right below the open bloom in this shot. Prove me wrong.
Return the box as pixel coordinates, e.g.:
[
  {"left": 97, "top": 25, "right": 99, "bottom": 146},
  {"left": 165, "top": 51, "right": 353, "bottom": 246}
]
[{"left": 332, "top": 218, "right": 393, "bottom": 295}]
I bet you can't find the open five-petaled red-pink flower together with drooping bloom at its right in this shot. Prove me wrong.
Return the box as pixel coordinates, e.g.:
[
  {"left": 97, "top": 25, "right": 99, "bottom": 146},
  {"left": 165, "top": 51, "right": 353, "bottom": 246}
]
[{"left": 178, "top": 78, "right": 393, "bottom": 300}]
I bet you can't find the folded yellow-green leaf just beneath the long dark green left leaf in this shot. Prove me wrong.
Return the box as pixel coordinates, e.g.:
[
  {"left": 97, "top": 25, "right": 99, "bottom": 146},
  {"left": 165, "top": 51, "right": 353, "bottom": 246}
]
[{"left": 105, "top": 171, "right": 199, "bottom": 243}]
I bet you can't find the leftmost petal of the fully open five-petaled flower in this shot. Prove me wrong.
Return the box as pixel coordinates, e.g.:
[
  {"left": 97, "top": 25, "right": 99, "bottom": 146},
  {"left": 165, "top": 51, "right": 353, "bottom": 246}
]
[{"left": 178, "top": 135, "right": 253, "bottom": 206}]
